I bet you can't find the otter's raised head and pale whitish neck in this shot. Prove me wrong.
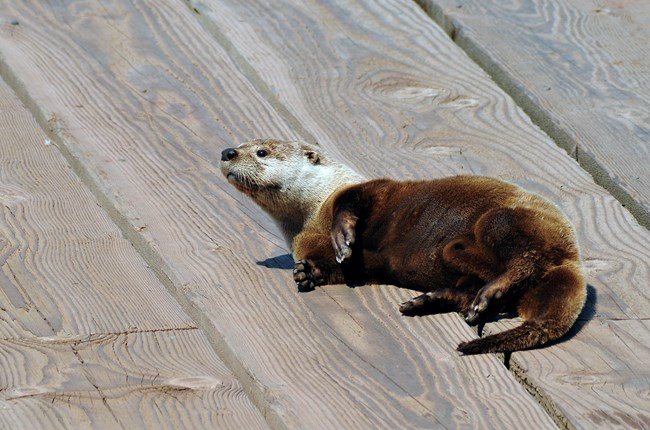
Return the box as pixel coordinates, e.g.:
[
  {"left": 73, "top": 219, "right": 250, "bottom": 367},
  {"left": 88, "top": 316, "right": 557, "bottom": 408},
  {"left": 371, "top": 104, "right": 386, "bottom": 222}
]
[{"left": 221, "top": 139, "right": 363, "bottom": 244}]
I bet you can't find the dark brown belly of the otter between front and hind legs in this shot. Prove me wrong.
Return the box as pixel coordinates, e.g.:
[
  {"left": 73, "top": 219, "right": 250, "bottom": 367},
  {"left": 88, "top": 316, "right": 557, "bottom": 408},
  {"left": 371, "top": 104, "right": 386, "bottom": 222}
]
[{"left": 358, "top": 178, "right": 503, "bottom": 291}]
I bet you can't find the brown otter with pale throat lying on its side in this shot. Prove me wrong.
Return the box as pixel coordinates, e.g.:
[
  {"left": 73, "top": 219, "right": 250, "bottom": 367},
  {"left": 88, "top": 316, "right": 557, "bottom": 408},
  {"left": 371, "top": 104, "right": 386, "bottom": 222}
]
[{"left": 221, "top": 139, "right": 587, "bottom": 354}]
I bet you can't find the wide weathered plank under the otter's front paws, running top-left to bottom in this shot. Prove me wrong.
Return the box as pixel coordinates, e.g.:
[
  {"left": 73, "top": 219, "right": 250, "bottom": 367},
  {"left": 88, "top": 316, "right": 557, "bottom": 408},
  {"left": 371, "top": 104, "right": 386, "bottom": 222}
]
[{"left": 0, "top": 0, "right": 553, "bottom": 428}]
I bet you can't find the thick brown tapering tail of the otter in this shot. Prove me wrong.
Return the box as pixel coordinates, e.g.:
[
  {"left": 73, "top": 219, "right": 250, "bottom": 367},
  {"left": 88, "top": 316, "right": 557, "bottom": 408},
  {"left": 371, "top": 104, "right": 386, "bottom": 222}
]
[{"left": 458, "top": 262, "right": 587, "bottom": 354}]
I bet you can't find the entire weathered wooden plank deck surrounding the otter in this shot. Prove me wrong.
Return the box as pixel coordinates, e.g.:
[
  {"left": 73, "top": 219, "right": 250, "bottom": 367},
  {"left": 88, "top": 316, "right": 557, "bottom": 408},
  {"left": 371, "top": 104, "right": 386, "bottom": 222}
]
[{"left": 0, "top": 0, "right": 650, "bottom": 429}]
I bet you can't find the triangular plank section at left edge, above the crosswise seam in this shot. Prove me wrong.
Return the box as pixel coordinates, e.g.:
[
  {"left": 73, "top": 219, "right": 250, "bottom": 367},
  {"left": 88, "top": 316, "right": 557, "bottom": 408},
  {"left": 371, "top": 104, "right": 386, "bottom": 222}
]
[{"left": 0, "top": 81, "right": 192, "bottom": 338}]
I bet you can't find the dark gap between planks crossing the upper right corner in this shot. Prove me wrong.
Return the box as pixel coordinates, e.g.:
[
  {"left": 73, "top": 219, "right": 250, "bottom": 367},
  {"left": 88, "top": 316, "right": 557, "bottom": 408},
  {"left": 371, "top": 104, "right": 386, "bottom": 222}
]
[{"left": 413, "top": 0, "right": 650, "bottom": 230}]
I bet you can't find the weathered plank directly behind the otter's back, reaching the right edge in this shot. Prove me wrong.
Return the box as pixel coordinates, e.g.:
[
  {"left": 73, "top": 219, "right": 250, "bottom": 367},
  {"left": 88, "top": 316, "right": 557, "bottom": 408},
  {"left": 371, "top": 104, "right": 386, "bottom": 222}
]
[{"left": 192, "top": 1, "right": 650, "bottom": 318}]
